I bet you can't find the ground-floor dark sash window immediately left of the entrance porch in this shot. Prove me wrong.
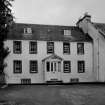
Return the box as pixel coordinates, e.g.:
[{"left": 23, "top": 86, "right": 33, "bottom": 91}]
[{"left": 30, "top": 60, "right": 38, "bottom": 73}]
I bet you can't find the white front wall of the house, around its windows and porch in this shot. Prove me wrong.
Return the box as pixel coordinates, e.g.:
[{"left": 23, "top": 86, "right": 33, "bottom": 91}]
[{"left": 5, "top": 40, "right": 94, "bottom": 83}]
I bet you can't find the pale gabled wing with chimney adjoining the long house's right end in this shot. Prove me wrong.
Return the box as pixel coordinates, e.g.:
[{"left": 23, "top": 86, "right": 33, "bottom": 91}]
[{"left": 77, "top": 14, "right": 105, "bottom": 82}]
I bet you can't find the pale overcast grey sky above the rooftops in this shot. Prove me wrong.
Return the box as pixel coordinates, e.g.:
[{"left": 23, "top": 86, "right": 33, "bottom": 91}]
[{"left": 12, "top": 0, "right": 105, "bottom": 26}]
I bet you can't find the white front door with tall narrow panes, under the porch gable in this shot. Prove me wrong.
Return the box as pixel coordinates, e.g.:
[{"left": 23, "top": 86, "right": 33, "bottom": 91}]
[{"left": 45, "top": 61, "right": 61, "bottom": 81}]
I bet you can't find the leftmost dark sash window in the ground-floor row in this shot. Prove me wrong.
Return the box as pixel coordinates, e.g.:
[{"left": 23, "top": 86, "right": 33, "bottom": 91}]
[{"left": 13, "top": 60, "right": 22, "bottom": 74}]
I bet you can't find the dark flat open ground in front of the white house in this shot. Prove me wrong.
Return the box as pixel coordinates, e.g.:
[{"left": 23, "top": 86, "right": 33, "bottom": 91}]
[{"left": 0, "top": 84, "right": 105, "bottom": 105}]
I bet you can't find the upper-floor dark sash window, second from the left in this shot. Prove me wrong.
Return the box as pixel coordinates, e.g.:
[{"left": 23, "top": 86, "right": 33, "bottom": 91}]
[{"left": 29, "top": 41, "right": 37, "bottom": 54}]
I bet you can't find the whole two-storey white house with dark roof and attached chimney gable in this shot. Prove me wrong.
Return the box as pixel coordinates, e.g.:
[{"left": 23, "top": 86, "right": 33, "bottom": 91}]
[{"left": 5, "top": 15, "right": 105, "bottom": 84}]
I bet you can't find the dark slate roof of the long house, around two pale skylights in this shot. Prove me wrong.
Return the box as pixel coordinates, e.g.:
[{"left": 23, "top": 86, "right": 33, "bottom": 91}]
[{"left": 7, "top": 23, "right": 92, "bottom": 41}]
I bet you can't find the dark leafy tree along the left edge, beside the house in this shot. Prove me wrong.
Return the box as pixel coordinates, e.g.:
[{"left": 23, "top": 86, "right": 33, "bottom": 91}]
[{"left": 0, "top": 0, "right": 14, "bottom": 74}]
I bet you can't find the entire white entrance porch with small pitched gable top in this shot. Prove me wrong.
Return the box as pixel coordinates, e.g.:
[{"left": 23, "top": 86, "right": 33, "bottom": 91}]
[{"left": 42, "top": 54, "right": 63, "bottom": 82}]
